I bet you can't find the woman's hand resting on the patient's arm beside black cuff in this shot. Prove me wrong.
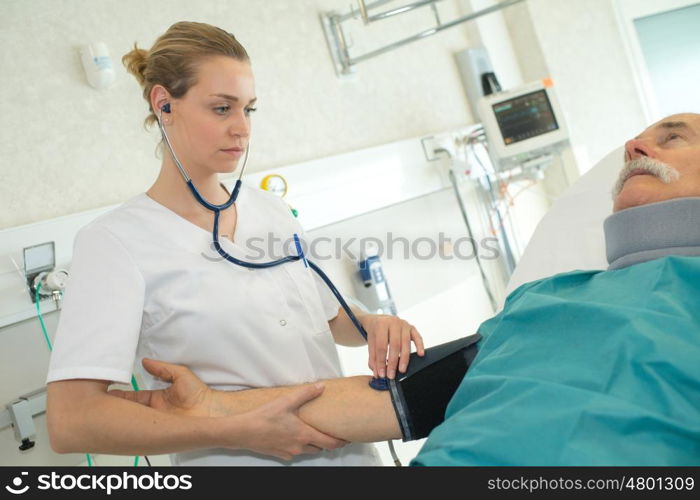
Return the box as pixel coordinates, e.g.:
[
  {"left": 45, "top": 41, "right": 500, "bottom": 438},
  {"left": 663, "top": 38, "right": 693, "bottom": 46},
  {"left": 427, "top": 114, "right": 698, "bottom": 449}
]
[{"left": 360, "top": 314, "right": 425, "bottom": 379}]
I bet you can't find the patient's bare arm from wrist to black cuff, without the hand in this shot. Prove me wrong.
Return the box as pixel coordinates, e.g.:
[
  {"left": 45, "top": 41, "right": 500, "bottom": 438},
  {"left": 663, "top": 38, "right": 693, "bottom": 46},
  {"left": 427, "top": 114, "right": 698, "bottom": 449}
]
[{"left": 212, "top": 376, "right": 401, "bottom": 442}]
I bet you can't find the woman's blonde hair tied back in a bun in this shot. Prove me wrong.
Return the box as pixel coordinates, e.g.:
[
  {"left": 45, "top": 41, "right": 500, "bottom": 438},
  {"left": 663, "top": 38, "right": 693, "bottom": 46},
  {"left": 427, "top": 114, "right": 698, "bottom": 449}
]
[{"left": 122, "top": 21, "right": 250, "bottom": 127}]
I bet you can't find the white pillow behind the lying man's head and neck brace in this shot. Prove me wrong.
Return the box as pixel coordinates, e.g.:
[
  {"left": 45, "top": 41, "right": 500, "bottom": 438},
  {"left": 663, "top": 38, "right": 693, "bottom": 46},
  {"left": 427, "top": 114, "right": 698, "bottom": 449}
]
[{"left": 506, "top": 147, "right": 624, "bottom": 294}]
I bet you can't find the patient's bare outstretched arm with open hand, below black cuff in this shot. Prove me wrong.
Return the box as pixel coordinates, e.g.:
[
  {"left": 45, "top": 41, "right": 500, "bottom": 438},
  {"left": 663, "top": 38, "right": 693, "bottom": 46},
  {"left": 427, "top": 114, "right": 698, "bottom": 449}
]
[{"left": 110, "top": 359, "right": 401, "bottom": 442}]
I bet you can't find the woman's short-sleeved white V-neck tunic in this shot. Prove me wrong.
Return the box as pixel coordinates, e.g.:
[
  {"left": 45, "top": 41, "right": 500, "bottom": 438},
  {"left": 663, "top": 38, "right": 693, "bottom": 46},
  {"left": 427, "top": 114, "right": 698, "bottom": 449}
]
[{"left": 48, "top": 187, "right": 379, "bottom": 465}]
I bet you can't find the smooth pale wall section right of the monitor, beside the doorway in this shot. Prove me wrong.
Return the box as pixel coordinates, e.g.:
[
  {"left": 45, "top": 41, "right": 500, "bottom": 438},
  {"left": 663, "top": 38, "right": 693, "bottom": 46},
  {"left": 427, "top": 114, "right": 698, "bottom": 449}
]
[{"left": 504, "top": 0, "right": 648, "bottom": 173}]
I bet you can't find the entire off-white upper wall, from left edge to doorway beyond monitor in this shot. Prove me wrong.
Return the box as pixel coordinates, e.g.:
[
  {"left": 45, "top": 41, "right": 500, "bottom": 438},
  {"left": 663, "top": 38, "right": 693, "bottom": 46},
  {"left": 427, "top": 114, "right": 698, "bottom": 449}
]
[{"left": 0, "top": 0, "right": 645, "bottom": 229}]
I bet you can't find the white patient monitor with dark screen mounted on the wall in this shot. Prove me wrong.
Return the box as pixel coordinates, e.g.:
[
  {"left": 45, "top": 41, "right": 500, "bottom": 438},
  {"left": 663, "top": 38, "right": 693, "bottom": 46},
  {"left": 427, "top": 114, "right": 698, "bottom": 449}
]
[{"left": 479, "top": 80, "right": 568, "bottom": 158}]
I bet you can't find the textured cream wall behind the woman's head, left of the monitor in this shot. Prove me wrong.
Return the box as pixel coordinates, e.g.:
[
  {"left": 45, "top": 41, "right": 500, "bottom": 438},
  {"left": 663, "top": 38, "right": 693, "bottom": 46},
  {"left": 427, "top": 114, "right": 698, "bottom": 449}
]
[{"left": 0, "top": 0, "right": 472, "bottom": 229}]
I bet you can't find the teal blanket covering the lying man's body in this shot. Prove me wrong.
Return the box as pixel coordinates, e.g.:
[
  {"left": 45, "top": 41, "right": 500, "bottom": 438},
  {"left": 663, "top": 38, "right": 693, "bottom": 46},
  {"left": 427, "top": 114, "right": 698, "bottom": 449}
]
[{"left": 412, "top": 257, "right": 700, "bottom": 466}]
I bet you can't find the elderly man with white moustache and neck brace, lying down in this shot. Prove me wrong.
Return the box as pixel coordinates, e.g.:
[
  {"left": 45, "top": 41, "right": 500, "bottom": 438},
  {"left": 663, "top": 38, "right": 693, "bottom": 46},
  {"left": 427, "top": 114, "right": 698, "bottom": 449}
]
[{"left": 105, "top": 114, "right": 700, "bottom": 465}]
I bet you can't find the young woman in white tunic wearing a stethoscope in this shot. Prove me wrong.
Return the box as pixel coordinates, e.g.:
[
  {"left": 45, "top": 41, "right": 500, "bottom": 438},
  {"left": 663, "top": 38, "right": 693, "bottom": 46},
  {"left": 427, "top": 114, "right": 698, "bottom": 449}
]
[{"left": 48, "top": 22, "right": 423, "bottom": 465}]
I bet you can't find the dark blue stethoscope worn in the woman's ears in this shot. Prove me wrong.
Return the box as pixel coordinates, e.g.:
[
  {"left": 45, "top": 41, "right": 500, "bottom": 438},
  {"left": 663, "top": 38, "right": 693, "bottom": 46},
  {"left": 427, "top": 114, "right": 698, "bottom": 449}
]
[{"left": 158, "top": 103, "right": 389, "bottom": 391}]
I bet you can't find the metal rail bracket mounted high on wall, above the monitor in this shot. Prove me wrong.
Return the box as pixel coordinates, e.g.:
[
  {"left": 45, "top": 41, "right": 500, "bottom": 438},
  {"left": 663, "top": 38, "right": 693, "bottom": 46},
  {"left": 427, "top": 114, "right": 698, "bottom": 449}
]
[{"left": 321, "top": 0, "right": 523, "bottom": 76}]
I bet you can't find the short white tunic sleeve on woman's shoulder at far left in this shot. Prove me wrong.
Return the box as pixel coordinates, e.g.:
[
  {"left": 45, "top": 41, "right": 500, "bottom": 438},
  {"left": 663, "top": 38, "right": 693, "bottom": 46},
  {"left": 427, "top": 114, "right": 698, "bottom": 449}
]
[{"left": 47, "top": 224, "right": 145, "bottom": 383}]
